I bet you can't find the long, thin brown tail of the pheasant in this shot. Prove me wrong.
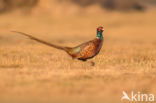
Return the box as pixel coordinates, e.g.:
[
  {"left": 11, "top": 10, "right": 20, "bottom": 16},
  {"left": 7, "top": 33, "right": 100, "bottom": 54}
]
[{"left": 11, "top": 31, "right": 66, "bottom": 51}]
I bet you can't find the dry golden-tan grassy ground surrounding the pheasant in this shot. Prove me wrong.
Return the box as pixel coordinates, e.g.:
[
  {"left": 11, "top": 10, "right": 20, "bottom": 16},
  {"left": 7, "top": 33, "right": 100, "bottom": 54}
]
[{"left": 0, "top": 10, "right": 156, "bottom": 103}]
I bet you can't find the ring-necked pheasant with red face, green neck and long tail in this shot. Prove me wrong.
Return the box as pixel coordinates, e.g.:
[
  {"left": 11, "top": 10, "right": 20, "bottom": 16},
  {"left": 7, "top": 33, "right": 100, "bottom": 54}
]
[{"left": 12, "top": 27, "right": 104, "bottom": 61}]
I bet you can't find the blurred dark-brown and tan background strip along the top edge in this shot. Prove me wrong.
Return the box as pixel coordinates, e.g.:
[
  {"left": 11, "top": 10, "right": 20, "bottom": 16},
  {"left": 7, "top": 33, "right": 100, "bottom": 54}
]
[{"left": 0, "top": 0, "right": 156, "bottom": 13}]
